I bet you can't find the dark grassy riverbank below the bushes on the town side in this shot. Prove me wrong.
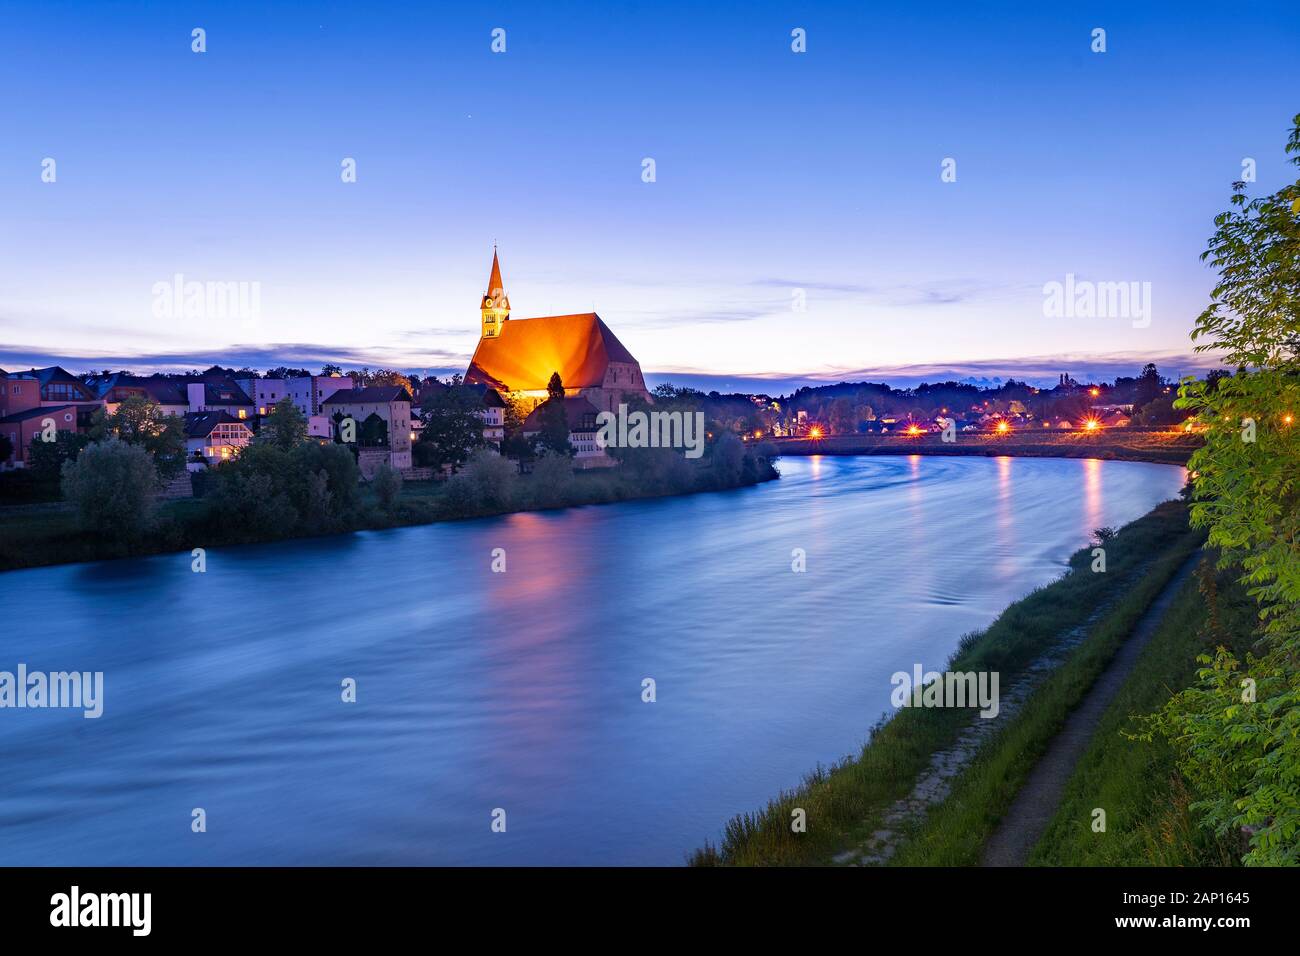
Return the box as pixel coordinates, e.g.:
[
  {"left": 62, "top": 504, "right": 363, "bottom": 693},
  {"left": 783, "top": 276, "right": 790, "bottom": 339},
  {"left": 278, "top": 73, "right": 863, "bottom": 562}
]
[{"left": 0, "top": 452, "right": 779, "bottom": 571}]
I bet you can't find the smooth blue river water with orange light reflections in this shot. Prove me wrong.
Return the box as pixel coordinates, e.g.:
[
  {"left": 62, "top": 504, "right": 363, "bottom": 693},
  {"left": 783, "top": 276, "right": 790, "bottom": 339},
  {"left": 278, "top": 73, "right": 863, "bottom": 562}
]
[{"left": 0, "top": 457, "right": 1184, "bottom": 865}]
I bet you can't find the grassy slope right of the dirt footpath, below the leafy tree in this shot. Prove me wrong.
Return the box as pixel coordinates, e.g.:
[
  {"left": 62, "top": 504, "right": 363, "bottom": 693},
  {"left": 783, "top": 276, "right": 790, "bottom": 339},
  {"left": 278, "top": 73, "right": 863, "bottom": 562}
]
[{"left": 1030, "top": 559, "right": 1256, "bottom": 866}]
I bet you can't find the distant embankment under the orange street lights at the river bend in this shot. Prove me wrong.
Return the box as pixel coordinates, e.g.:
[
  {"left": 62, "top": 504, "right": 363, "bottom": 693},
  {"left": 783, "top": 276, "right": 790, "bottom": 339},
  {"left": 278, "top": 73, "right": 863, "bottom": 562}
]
[{"left": 768, "top": 428, "right": 1204, "bottom": 464}]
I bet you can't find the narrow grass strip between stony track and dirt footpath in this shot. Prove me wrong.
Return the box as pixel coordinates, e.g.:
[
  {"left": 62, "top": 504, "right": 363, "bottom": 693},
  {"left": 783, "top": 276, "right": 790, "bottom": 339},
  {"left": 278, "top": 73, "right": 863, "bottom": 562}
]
[{"left": 892, "top": 532, "right": 1201, "bottom": 866}]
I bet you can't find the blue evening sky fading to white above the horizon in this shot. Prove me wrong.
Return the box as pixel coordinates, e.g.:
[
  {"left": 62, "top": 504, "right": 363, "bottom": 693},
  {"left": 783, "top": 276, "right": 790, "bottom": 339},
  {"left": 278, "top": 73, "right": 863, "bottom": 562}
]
[{"left": 0, "top": 3, "right": 1300, "bottom": 384}]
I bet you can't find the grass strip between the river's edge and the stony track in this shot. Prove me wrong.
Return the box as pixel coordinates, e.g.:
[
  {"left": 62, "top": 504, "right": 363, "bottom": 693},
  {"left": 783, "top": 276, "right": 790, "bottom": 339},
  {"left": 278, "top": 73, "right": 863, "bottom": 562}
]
[{"left": 690, "top": 502, "right": 1199, "bottom": 866}]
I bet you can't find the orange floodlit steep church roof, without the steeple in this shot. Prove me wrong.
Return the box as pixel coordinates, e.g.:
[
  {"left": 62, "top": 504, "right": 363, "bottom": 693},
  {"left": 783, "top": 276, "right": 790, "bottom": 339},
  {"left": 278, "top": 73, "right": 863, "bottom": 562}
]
[{"left": 465, "top": 312, "right": 637, "bottom": 392}]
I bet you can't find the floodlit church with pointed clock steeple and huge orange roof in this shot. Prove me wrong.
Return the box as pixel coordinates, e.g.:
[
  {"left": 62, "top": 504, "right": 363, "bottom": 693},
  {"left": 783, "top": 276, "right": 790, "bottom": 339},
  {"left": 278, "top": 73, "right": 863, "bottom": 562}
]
[{"left": 465, "top": 248, "right": 653, "bottom": 412}]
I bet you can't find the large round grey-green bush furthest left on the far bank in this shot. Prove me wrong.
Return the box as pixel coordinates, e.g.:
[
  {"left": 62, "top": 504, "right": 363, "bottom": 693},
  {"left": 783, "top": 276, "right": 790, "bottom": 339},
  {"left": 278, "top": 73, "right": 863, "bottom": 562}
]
[{"left": 62, "top": 438, "right": 157, "bottom": 540}]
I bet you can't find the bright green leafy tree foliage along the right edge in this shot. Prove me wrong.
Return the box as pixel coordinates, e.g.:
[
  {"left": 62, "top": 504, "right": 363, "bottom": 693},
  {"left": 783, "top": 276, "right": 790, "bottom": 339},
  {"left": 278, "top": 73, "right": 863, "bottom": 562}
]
[{"left": 1151, "top": 116, "right": 1300, "bottom": 865}]
